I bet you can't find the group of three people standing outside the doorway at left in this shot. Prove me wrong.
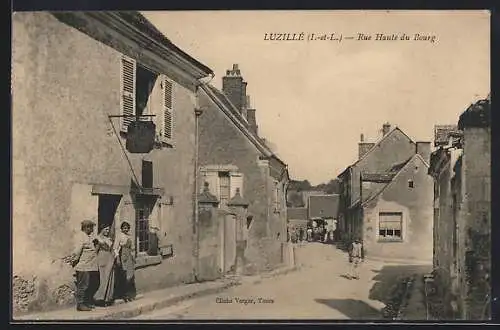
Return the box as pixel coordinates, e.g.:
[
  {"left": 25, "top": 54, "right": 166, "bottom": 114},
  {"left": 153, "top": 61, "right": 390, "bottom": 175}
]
[{"left": 69, "top": 220, "right": 136, "bottom": 311}]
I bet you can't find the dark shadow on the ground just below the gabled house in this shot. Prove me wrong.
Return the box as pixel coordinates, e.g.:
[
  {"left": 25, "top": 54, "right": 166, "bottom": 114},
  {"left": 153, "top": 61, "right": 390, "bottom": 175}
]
[{"left": 368, "top": 265, "right": 432, "bottom": 304}]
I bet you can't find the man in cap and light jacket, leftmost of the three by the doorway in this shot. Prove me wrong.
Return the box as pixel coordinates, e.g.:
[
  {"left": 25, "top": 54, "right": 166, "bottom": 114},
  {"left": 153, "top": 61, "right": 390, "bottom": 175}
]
[{"left": 71, "top": 220, "right": 99, "bottom": 311}]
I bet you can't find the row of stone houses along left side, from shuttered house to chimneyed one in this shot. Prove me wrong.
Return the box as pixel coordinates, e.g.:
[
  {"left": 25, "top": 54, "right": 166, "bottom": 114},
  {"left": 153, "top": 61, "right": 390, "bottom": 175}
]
[{"left": 12, "top": 12, "right": 289, "bottom": 310}]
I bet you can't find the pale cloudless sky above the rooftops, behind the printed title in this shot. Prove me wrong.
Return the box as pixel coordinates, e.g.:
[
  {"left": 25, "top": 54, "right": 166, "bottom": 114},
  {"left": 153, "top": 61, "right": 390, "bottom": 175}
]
[{"left": 142, "top": 11, "right": 490, "bottom": 184}]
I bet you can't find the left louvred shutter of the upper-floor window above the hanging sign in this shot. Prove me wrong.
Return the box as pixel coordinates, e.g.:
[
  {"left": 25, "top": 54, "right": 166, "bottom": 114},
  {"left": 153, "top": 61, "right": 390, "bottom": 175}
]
[{"left": 121, "top": 57, "right": 137, "bottom": 132}]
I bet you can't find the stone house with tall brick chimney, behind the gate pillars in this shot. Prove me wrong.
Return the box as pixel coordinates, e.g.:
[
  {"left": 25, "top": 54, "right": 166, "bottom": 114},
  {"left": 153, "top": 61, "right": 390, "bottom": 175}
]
[{"left": 198, "top": 64, "right": 289, "bottom": 270}]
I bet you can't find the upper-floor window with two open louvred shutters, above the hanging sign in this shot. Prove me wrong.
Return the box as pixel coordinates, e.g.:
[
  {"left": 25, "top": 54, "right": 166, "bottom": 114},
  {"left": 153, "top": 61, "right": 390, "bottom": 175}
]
[{"left": 121, "top": 57, "right": 174, "bottom": 143}]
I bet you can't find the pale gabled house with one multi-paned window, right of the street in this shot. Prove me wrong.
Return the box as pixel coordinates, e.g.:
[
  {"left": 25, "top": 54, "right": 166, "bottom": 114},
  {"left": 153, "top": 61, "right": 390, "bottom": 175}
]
[{"left": 338, "top": 123, "right": 432, "bottom": 262}]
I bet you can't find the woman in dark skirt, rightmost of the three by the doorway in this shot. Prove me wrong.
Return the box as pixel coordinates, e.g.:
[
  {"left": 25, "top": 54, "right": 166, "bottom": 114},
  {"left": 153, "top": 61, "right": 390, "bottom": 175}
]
[{"left": 114, "top": 221, "right": 136, "bottom": 302}]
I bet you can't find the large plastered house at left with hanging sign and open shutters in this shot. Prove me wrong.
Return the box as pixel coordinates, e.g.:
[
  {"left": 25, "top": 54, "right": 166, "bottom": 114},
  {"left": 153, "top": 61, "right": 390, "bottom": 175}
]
[{"left": 12, "top": 12, "right": 212, "bottom": 310}]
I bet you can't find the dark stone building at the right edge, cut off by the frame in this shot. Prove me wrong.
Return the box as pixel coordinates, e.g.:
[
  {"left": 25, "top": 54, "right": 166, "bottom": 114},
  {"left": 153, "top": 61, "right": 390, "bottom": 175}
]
[{"left": 429, "top": 97, "right": 491, "bottom": 320}]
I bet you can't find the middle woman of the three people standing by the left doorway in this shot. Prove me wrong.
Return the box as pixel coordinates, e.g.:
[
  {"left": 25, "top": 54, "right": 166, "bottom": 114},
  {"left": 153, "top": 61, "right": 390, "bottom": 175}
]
[{"left": 94, "top": 226, "right": 115, "bottom": 306}]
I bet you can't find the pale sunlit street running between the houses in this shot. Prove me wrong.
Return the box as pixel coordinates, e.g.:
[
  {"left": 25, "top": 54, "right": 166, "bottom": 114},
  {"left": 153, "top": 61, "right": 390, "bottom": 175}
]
[{"left": 136, "top": 243, "right": 427, "bottom": 320}]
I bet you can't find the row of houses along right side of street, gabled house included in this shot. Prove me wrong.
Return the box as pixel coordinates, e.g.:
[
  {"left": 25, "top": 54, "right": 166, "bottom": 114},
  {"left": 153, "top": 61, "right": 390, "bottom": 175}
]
[{"left": 330, "top": 96, "right": 491, "bottom": 320}]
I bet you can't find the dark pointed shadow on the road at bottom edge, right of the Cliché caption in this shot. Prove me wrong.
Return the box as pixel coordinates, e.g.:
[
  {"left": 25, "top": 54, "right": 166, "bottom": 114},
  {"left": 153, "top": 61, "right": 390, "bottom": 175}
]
[{"left": 315, "top": 299, "right": 382, "bottom": 320}]
